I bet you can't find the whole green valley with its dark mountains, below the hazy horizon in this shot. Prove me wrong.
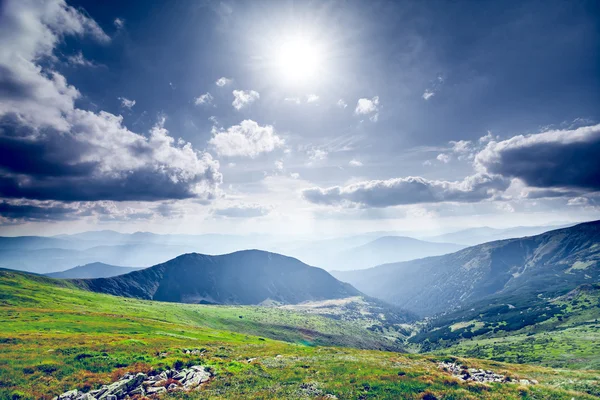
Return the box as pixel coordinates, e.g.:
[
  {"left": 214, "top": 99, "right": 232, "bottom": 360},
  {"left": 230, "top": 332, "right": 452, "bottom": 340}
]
[{"left": 0, "top": 222, "right": 600, "bottom": 399}]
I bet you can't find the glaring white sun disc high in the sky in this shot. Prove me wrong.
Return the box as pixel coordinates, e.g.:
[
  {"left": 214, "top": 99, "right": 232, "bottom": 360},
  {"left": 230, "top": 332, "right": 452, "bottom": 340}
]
[{"left": 276, "top": 37, "right": 321, "bottom": 82}]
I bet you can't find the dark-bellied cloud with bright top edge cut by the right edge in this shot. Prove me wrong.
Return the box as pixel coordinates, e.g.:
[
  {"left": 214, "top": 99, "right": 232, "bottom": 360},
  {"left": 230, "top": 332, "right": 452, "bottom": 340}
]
[{"left": 475, "top": 124, "right": 600, "bottom": 191}]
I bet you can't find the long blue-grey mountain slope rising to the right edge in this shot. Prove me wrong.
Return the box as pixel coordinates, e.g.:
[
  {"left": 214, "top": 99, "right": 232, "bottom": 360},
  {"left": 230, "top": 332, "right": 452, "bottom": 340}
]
[{"left": 333, "top": 221, "right": 600, "bottom": 316}]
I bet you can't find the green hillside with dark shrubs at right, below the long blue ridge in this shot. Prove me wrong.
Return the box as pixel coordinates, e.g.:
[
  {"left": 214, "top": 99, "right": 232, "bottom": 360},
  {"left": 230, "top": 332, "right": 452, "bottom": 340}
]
[{"left": 432, "top": 283, "right": 600, "bottom": 369}]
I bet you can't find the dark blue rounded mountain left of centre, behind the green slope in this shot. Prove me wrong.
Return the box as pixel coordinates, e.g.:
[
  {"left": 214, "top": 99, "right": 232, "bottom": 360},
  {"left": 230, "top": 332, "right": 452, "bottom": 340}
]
[{"left": 74, "top": 250, "right": 361, "bottom": 304}]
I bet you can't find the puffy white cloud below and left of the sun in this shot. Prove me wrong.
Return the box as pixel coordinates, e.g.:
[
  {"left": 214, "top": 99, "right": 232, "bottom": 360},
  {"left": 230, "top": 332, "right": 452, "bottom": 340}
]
[{"left": 209, "top": 120, "right": 284, "bottom": 158}]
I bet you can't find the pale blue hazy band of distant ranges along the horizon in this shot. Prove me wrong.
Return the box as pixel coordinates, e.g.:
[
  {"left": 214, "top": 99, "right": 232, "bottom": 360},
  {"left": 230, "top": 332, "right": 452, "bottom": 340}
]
[{"left": 0, "top": 223, "right": 564, "bottom": 273}]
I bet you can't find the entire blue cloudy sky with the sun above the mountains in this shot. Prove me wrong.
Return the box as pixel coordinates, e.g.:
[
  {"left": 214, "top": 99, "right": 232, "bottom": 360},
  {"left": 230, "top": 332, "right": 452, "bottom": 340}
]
[{"left": 0, "top": 0, "right": 600, "bottom": 236}]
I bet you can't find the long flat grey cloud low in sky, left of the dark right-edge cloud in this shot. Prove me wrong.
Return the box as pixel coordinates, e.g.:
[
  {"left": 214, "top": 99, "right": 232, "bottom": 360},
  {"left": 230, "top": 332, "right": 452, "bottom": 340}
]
[{"left": 302, "top": 174, "right": 509, "bottom": 208}]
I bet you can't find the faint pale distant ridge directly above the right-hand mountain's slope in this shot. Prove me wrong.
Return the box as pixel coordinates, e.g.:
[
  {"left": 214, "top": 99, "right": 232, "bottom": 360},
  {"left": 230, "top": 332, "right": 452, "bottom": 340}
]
[{"left": 424, "top": 224, "right": 575, "bottom": 246}]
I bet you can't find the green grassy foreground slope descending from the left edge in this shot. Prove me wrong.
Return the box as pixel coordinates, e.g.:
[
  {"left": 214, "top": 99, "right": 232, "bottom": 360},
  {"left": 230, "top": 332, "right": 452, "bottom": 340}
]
[{"left": 0, "top": 271, "right": 598, "bottom": 400}]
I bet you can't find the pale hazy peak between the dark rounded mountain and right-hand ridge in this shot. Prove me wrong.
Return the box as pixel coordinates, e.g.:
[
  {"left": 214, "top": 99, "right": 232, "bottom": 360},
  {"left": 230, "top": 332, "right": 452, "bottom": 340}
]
[{"left": 323, "top": 236, "right": 466, "bottom": 270}]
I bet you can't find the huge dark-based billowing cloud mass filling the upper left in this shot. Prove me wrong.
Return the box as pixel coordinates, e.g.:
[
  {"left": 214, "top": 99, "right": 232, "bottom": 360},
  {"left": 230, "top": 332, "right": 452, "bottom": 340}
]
[{"left": 0, "top": 0, "right": 222, "bottom": 202}]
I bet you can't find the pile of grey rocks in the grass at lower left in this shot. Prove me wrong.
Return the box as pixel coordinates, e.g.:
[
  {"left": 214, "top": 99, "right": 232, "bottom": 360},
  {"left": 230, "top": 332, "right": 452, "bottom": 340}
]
[{"left": 53, "top": 365, "right": 212, "bottom": 400}]
